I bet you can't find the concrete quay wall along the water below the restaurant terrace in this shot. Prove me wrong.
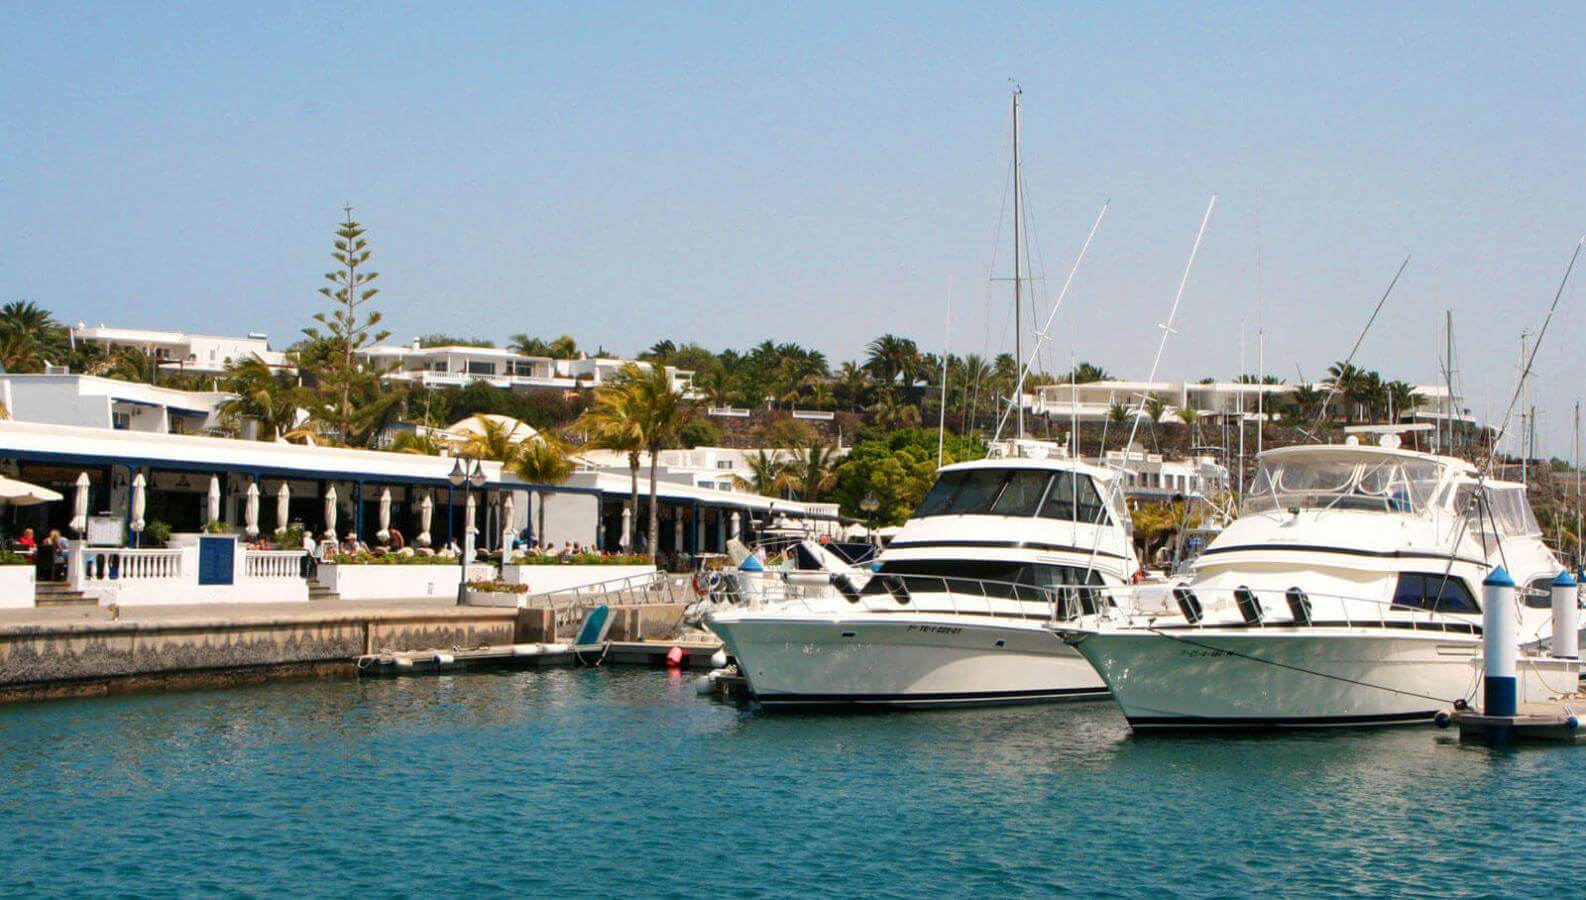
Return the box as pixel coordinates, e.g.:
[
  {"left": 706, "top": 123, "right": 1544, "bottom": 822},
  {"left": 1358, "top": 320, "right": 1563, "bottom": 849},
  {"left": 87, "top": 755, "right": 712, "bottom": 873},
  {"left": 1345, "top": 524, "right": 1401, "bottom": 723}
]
[{"left": 0, "top": 597, "right": 717, "bottom": 702}]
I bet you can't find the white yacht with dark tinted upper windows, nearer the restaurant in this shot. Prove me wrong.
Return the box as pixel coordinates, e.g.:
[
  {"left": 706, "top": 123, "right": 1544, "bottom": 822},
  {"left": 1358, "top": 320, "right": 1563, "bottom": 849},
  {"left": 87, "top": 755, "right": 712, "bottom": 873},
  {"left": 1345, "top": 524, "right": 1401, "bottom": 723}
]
[{"left": 706, "top": 441, "right": 1140, "bottom": 706}]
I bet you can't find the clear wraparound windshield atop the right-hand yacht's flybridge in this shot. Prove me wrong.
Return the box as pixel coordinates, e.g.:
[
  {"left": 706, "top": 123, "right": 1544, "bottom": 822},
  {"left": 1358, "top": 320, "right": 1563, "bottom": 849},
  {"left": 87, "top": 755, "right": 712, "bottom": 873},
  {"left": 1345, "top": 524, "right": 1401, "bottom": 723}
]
[{"left": 1243, "top": 456, "right": 1443, "bottom": 514}]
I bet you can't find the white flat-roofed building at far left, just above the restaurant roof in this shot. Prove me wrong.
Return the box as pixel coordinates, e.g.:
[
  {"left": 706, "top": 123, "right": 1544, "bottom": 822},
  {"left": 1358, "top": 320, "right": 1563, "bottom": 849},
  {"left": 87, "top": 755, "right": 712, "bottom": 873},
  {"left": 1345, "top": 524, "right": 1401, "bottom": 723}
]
[{"left": 0, "top": 375, "right": 232, "bottom": 435}]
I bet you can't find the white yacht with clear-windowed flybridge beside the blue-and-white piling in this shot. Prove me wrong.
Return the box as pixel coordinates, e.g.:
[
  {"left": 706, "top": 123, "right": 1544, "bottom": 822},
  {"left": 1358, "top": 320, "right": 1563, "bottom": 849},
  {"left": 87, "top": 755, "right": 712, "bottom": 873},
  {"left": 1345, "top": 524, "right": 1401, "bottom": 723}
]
[{"left": 1056, "top": 435, "right": 1578, "bottom": 730}]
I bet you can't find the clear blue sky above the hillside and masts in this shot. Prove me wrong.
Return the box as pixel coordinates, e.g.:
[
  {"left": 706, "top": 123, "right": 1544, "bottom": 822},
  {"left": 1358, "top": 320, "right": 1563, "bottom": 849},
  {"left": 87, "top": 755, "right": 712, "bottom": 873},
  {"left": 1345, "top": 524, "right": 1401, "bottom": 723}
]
[{"left": 0, "top": 2, "right": 1586, "bottom": 452}]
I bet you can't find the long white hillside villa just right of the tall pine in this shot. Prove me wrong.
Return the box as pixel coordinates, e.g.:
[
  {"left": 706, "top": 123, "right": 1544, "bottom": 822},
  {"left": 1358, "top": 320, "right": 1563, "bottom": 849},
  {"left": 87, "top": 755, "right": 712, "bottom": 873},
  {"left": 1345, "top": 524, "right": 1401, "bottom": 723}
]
[{"left": 363, "top": 341, "right": 695, "bottom": 397}]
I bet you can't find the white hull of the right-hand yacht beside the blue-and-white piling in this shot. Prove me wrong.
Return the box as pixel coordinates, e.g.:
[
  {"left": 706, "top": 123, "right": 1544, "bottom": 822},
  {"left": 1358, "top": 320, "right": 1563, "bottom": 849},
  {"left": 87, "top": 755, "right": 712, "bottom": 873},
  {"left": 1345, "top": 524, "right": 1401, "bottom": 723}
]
[{"left": 1072, "top": 629, "right": 1576, "bottom": 730}]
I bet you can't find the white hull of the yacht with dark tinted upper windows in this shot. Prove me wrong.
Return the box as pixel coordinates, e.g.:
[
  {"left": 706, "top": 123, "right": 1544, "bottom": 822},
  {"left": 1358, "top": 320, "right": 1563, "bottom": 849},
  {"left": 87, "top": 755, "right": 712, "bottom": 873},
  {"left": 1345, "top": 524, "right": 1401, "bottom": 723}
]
[{"left": 707, "top": 613, "right": 1107, "bottom": 708}]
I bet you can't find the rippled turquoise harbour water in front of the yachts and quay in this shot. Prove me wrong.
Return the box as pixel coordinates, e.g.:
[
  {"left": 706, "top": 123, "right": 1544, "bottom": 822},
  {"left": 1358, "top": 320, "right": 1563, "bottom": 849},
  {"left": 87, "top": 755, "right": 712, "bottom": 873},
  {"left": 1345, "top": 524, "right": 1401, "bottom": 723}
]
[{"left": 0, "top": 670, "right": 1586, "bottom": 897}]
